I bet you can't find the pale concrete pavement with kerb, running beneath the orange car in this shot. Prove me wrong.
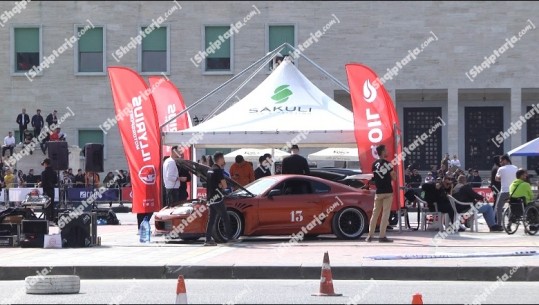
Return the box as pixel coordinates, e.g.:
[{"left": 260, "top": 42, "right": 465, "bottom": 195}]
[{"left": 0, "top": 214, "right": 539, "bottom": 281}]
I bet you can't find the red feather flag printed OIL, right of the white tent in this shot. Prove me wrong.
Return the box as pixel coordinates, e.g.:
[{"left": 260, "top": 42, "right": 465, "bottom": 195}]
[{"left": 346, "top": 64, "right": 404, "bottom": 210}]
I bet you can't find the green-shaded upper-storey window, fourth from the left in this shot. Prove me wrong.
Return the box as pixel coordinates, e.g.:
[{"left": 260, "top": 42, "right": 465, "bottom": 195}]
[{"left": 204, "top": 26, "right": 232, "bottom": 72}]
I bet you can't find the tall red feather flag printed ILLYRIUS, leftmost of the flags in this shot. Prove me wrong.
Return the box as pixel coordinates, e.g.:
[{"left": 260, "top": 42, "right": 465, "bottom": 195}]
[{"left": 108, "top": 67, "right": 161, "bottom": 213}]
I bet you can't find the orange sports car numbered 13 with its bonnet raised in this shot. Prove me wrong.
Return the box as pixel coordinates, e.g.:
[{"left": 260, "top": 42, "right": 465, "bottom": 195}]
[{"left": 155, "top": 160, "right": 374, "bottom": 242}]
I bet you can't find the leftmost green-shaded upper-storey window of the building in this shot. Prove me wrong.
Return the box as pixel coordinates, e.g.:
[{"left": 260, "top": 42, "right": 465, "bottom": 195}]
[{"left": 13, "top": 27, "right": 41, "bottom": 72}]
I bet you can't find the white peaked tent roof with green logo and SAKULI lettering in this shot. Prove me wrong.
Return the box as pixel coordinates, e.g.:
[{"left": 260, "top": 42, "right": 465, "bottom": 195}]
[{"left": 164, "top": 61, "right": 356, "bottom": 148}]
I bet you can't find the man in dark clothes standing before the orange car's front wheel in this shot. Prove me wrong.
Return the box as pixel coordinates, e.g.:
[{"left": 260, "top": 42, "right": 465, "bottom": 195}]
[{"left": 204, "top": 151, "right": 237, "bottom": 246}]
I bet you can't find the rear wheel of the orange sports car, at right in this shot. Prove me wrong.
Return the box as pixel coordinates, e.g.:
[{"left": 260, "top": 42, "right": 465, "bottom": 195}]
[{"left": 332, "top": 208, "right": 367, "bottom": 239}]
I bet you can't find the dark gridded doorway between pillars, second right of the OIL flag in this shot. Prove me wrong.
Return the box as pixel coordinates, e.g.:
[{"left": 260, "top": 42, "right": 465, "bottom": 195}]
[{"left": 464, "top": 107, "right": 503, "bottom": 170}]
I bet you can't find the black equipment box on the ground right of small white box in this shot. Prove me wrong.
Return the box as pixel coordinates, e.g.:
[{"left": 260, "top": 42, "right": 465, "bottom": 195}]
[{"left": 58, "top": 211, "right": 97, "bottom": 248}]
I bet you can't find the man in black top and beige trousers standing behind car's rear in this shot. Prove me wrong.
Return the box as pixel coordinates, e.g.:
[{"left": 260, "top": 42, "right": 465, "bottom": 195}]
[{"left": 365, "top": 145, "right": 397, "bottom": 243}]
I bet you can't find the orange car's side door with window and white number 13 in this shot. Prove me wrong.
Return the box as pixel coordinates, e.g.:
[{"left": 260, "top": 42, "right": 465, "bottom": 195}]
[{"left": 258, "top": 178, "right": 322, "bottom": 234}]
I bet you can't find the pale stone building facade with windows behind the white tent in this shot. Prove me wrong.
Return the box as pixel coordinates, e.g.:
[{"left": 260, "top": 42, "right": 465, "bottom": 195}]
[{"left": 0, "top": 1, "right": 539, "bottom": 171}]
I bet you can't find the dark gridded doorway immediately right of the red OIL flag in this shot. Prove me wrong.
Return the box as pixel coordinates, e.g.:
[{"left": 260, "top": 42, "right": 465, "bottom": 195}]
[{"left": 402, "top": 107, "right": 443, "bottom": 170}]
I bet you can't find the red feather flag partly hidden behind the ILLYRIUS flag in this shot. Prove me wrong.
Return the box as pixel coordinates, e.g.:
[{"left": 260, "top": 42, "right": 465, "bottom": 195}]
[{"left": 148, "top": 76, "right": 191, "bottom": 160}]
